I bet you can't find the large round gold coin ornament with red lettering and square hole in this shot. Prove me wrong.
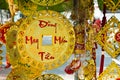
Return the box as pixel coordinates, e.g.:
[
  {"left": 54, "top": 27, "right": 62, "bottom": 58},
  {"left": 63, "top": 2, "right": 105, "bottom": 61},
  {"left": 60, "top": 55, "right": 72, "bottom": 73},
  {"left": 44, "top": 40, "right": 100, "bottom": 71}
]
[{"left": 17, "top": 10, "right": 75, "bottom": 70}]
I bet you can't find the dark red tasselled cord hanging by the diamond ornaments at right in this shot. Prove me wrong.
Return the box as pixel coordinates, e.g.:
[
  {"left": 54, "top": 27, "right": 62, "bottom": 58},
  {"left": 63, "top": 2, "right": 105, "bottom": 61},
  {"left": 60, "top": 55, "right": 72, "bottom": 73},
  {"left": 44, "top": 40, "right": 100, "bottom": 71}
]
[{"left": 99, "top": 4, "right": 106, "bottom": 74}]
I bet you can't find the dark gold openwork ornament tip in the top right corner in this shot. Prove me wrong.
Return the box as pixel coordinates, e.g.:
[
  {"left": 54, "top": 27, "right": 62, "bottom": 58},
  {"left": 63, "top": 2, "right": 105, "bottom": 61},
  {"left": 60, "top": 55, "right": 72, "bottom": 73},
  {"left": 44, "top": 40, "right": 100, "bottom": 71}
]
[{"left": 104, "top": 0, "right": 120, "bottom": 12}]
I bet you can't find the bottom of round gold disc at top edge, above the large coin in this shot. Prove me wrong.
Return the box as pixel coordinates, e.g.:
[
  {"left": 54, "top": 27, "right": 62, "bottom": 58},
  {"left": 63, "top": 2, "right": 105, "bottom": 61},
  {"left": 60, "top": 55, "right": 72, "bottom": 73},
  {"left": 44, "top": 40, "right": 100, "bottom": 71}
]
[{"left": 31, "top": 0, "right": 64, "bottom": 6}]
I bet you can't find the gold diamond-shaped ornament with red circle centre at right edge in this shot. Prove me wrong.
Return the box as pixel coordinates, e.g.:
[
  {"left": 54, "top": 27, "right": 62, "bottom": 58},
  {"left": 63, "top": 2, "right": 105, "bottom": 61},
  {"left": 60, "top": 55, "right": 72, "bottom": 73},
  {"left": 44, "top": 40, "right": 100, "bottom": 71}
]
[{"left": 95, "top": 16, "right": 120, "bottom": 58}]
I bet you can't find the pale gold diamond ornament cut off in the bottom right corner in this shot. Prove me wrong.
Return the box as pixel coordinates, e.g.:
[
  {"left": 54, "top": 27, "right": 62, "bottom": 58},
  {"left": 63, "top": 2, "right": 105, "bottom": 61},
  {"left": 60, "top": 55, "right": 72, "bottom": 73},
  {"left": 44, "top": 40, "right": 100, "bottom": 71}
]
[{"left": 97, "top": 62, "right": 120, "bottom": 80}]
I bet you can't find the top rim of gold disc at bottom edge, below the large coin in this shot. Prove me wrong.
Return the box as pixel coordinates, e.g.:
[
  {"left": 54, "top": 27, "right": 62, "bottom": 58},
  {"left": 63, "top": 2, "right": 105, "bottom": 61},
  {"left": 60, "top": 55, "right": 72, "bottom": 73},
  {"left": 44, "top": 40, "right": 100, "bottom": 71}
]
[{"left": 35, "top": 74, "right": 64, "bottom": 80}]
